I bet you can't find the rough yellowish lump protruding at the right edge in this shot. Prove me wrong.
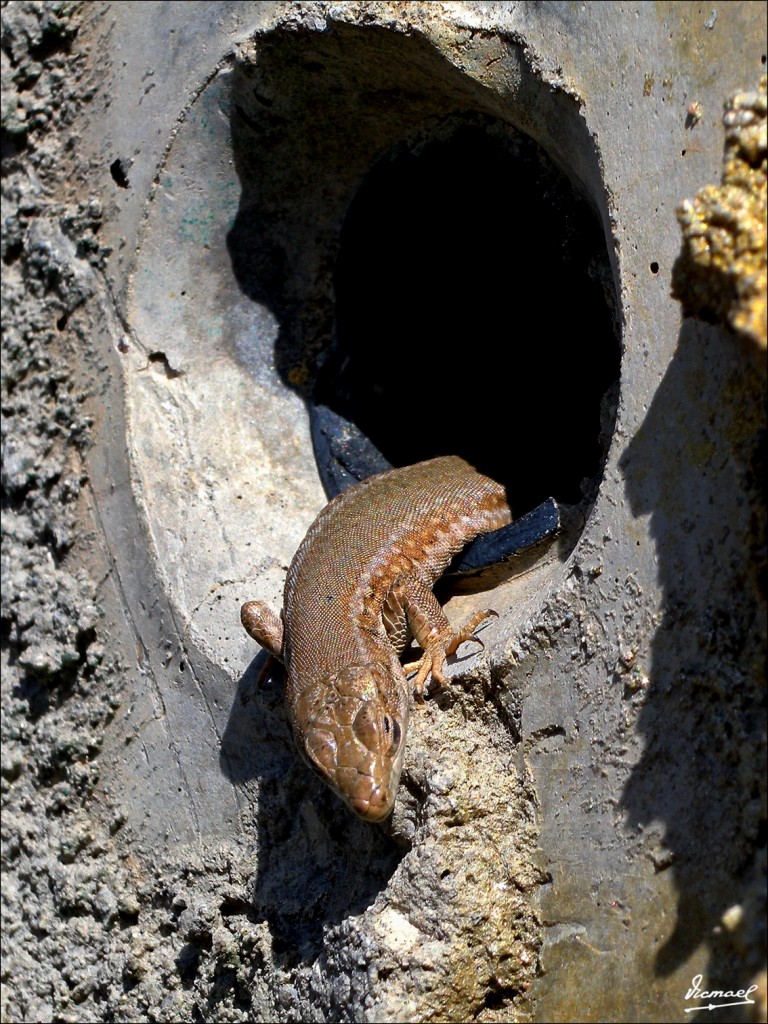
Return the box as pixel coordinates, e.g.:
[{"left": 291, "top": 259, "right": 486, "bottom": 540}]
[{"left": 672, "top": 76, "right": 768, "bottom": 349}]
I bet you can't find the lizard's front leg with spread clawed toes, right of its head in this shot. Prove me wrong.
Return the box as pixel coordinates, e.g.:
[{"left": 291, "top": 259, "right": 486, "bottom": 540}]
[{"left": 385, "top": 575, "right": 497, "bottom": 700}]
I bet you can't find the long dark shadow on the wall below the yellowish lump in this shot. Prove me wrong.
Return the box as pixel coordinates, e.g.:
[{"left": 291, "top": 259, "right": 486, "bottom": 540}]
[{"left": 622, "top": 321, "right": 766, "bottom": 990}]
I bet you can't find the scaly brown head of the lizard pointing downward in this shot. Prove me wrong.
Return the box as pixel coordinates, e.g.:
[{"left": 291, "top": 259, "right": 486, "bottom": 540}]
[{"left": 292, "top": 663, "right": 409, "bottom": 821}]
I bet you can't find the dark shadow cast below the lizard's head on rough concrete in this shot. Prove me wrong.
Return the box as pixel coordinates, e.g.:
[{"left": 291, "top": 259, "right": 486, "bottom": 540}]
[{"left": 220, "top": 653, "right": 404, "bottom": 964}]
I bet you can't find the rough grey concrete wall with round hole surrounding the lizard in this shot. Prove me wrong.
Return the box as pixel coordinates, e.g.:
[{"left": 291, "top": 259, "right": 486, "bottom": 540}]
[{"left": 2, "top": 0, "right": 766, "bottom": 1022}]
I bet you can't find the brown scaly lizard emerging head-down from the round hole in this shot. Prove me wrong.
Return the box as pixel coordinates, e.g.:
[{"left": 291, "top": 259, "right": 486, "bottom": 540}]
[{"left": 241, "top": 456, "right": 512, "bottom": 821}]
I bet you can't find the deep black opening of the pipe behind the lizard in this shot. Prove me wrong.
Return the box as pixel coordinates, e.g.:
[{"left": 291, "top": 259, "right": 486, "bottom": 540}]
[{"left": 323, "top": 123, "right": 620, "bottom": 514}]
